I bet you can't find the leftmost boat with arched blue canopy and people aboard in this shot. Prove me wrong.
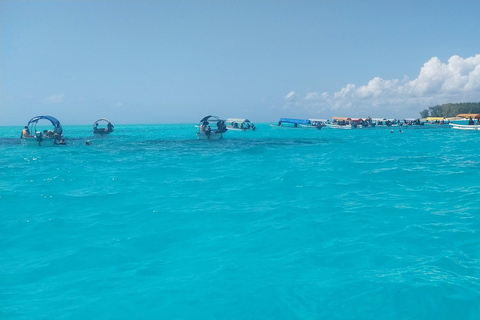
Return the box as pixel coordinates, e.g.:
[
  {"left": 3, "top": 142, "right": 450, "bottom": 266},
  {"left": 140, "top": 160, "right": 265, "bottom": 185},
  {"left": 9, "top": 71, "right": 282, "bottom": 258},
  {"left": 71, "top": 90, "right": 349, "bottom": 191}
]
[{"left": 20, "top": 116, "right": 65, "bottom": 147}]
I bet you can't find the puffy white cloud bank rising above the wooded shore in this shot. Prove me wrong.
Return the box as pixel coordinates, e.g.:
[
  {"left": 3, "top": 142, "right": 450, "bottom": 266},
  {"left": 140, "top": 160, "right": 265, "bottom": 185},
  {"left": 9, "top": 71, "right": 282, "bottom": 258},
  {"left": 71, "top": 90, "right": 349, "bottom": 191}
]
[{"left": 284, "top": 54, "right": 480, "bottom": 117}]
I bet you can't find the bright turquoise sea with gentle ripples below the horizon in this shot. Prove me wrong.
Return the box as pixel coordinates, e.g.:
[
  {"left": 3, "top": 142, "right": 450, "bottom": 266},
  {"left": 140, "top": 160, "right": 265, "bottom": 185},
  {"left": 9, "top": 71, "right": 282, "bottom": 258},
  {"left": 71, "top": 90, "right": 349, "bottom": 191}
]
[{"left": 0, "top": 124, "right": 480, "bottom": 320}]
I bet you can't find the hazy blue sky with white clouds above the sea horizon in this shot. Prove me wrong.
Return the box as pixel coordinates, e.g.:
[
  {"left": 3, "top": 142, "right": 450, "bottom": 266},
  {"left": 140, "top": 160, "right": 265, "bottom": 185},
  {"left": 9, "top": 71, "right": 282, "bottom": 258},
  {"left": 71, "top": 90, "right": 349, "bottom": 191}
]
[{"left": 0, "top": 0, "right": 480, "bottom": 125}]
